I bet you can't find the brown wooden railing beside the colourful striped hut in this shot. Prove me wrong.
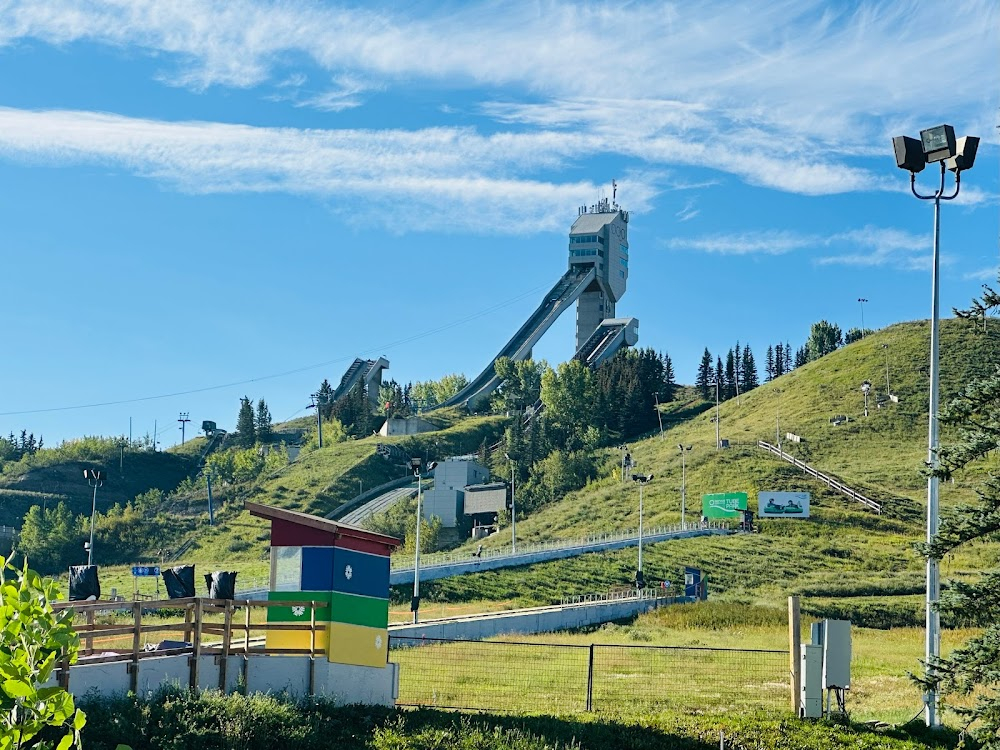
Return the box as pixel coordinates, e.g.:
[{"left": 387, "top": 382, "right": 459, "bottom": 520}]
[{"left": 53, "top": 597, "right": 330, "bottom": 694}]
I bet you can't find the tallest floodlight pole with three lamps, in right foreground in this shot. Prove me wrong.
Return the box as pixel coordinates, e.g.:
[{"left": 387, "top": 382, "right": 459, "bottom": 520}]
[{"left": 892, "top": 125, "right": 979, "bottom": 727}]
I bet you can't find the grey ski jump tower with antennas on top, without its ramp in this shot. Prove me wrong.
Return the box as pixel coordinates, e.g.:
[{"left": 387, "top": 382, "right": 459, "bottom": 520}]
[{"left": 569, "top": 191, "right": 628, "bottom": 349}]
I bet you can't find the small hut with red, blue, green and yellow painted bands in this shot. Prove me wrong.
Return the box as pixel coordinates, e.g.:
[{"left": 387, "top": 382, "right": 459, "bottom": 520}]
[{"left": 246, "top": 502, "right": 400, "bottom": 668}]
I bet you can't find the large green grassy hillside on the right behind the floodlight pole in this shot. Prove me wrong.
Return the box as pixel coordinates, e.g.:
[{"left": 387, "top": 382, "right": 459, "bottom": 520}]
[{"left": 416, "top": 321, "right": 1000, "bottom": 624}]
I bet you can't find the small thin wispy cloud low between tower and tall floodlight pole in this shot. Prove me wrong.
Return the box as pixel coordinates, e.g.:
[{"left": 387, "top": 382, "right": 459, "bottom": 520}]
[{"left": 667, "top": 227, "right": 930, "bottom": 270}]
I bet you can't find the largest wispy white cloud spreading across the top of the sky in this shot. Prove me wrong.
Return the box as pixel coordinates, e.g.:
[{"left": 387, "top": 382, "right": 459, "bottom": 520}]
[{"left": 0, "top": 0, "right": 988, "bottom": 200}]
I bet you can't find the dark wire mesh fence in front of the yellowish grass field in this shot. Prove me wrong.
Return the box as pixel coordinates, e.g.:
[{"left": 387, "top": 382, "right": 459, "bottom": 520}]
[{"left": 389, "top": 635, "right": 789, "bottom": 713}]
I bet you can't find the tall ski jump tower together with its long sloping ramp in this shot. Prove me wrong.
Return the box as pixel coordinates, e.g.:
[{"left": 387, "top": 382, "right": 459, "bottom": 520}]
[{"left": 442, "top": 199, "right": 639, "bottom": 410}]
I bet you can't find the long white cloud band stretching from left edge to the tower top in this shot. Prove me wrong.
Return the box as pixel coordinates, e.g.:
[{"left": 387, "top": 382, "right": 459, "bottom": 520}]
[{"left": 0, "top": 108, "right": 656, "bottom": 233}]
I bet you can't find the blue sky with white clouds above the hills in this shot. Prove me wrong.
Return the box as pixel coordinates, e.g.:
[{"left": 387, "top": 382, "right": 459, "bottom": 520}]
[{"left": 0, "top": 0, "right": 1000, "bottom": 446}]
